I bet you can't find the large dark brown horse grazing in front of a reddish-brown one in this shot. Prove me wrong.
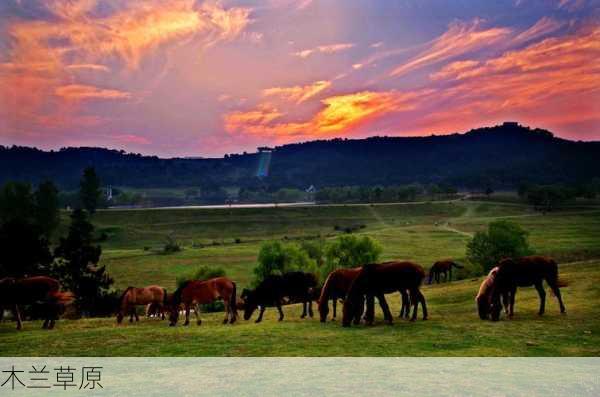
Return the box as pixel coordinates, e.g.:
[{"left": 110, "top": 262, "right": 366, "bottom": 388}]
[{"left": 342, "top": 262, "right": 427, "bottom": 327}]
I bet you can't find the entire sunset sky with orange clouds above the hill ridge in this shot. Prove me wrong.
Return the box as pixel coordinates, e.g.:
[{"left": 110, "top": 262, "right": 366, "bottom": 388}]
[{"left": 0, "top": 0, "right": 600, "bottom": 157}]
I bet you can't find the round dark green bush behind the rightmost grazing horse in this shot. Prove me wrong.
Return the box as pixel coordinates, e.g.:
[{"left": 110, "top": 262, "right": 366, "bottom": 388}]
[{"left": 467, "top": 220, "right": 532, "bottom": 272}]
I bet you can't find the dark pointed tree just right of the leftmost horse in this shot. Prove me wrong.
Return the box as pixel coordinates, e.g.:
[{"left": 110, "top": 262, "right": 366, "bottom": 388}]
[{"left": 54, "top": 209, "right": 113, "bottom": 315}]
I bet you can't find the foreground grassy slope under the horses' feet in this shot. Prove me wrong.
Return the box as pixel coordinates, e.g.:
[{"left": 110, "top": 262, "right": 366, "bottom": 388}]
[{"left": 0, "top": 261, "right": 600, "bottom": 356}]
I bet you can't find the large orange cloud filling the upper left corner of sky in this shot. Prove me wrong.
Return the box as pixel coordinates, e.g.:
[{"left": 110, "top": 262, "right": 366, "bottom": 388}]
[{"left": 0, "top": 0, "right": 250, "bottom": 125}]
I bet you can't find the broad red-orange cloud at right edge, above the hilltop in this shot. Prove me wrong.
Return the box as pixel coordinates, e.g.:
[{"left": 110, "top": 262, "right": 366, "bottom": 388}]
[{"left": 422, "top": 26, "right": 600, "bottom": 133}]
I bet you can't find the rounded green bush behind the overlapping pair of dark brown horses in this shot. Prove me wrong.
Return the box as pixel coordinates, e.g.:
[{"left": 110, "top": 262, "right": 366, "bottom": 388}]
[{"left": 322, "top": 235, "right": 381, "bottom": 274}]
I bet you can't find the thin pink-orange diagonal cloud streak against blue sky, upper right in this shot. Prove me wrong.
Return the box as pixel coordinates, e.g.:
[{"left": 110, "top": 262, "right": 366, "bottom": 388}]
[{"left": 390, "top": 19, "right": 511, "bottom": 76}]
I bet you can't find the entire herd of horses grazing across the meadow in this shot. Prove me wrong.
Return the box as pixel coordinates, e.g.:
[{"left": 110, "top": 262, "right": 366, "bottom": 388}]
[{"left": 0, "top": 256, "right": 566, "bottom": 329}]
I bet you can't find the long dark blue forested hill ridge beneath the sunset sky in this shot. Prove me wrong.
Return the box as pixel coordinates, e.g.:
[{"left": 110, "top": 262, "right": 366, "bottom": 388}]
[{"left": 0, "top": 124, "right": 600, "bottom": 188}]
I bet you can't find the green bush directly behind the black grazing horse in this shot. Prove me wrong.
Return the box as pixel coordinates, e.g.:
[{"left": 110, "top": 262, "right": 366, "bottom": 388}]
[{"left": 254, "top": 241, "right": 317, "bottom": 283}]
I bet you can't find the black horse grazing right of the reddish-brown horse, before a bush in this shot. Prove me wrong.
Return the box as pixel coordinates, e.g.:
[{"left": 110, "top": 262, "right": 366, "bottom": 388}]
[{"left": 242, "top": 272, "right": 317, "bottom": 323}]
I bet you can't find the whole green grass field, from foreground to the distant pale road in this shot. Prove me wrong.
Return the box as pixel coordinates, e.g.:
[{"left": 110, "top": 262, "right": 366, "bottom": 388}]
[{"left": 0, "top": 201, "right": 600, "bottom": 356}]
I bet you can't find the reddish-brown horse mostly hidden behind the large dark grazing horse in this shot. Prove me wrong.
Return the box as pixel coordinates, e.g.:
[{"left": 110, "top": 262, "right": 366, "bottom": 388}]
[{"left": 317, "top": 267, "right": 410, "bottom": 324}]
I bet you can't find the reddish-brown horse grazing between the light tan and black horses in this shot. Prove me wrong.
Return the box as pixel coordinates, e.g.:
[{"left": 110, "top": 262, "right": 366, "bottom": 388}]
[{"left": 169, "top": 277, "right": 237, "bottom": 326}]
